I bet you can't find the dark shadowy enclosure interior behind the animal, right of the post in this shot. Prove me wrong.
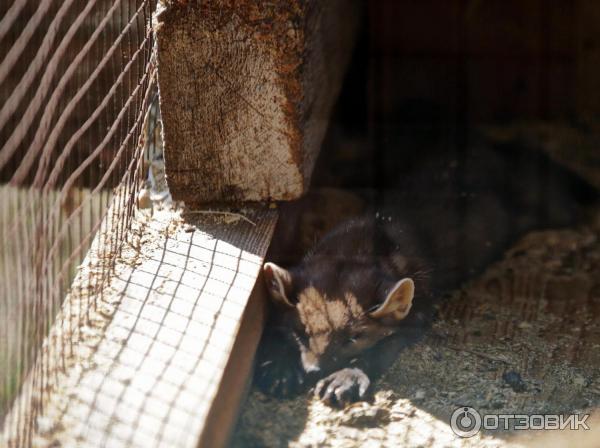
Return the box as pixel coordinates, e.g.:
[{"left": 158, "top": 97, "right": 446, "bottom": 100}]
[{"left": 312, "top": 0, "right": 600, "bottom": 189}]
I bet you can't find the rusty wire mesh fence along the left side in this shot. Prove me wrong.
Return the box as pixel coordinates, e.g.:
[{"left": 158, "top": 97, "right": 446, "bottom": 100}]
[{"left": 0, "top": 0, "right": 158, "bottom": 444}]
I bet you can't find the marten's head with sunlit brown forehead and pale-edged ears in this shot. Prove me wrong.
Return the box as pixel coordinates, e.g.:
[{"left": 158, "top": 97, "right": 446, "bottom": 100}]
[{"left": 263, "top": 263, "right": 415, "bottom": 373}]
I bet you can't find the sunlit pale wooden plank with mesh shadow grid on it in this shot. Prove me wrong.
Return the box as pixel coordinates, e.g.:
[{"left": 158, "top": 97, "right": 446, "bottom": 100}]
[{"left": 5, "top": 204, "right": 277, "bottom": 448}]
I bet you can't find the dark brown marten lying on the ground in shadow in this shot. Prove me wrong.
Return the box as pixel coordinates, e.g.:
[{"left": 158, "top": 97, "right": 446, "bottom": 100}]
[{"left": 256, "top": 144, "right": 596, "bottom": 405}]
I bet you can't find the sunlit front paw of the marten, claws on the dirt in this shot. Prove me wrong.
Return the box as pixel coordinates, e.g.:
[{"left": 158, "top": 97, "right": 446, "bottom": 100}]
[{"left": 315, "top": 368, "right": 371, "bottom": 406}]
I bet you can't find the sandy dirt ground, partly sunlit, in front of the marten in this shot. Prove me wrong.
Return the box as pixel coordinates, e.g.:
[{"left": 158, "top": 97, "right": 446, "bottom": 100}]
[{"left": 231, "top": 210, "right": 600, "bottom": 447}]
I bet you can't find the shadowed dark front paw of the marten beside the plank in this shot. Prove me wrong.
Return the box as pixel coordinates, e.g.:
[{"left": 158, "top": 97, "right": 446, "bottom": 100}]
[{"left": 255, "top": 360, "right": 305, "bottom": 398}]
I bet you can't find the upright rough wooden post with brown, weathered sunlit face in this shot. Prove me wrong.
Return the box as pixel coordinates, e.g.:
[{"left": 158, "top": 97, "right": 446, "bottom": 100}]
[{"left": 157, "top": 0, "right": 360, "bottom": 202}]
